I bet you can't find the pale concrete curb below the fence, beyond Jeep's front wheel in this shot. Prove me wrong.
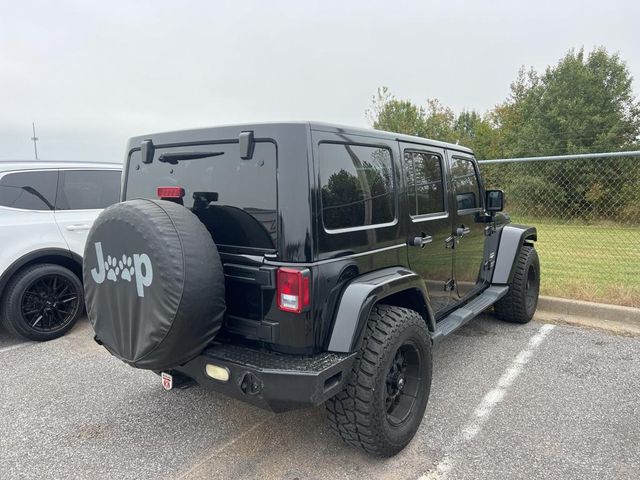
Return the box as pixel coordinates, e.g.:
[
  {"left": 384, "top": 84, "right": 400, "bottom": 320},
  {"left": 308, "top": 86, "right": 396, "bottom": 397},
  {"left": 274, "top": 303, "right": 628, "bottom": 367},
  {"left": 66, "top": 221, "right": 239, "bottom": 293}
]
[{"left": 536, "top": 296, "right": 640, "bottom": 336}]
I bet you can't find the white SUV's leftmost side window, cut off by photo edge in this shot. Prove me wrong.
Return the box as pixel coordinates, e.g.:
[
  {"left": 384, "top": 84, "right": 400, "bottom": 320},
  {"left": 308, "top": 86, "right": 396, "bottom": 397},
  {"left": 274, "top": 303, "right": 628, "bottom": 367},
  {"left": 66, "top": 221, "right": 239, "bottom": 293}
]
[{"left": 0, "top": 170, "right": 58, "bottom": 210}]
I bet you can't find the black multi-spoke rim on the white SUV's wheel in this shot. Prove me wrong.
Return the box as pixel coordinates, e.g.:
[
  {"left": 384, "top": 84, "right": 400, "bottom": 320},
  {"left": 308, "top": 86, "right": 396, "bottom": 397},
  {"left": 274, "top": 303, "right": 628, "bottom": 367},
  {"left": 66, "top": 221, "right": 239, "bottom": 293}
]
[{"left": 20, "top": 274, "right": 79, "bottom": 332}]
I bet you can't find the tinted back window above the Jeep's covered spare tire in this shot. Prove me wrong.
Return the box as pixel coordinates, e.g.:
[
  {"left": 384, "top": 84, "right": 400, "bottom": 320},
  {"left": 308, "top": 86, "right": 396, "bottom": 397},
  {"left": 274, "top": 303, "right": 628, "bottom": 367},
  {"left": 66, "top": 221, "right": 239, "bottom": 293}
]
[{"left": 125, "top": 141, "right": 277, "bottom": 250}]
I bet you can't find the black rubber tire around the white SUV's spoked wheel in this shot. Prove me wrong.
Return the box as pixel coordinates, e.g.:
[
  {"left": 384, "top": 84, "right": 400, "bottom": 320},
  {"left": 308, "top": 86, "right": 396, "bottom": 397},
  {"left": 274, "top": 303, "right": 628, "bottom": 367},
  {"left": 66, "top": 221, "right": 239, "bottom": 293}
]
[{"left": 0, "top": 263, "right": 84, "bottom": 342}]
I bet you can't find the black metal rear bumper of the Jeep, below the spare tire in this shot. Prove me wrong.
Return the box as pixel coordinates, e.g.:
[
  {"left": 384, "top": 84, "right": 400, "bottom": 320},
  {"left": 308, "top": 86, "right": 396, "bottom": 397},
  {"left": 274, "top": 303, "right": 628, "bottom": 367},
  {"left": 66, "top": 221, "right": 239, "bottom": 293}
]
[{"left": 173, "top": 344, "right": 356, "bottom": 412}]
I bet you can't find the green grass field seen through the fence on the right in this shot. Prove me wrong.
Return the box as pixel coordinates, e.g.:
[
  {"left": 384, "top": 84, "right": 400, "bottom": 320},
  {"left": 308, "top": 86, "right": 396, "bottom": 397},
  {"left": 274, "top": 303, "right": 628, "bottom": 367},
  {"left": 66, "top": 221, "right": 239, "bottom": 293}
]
[{"left": 513, "top": 217, "right": 640, "bottom": 307}]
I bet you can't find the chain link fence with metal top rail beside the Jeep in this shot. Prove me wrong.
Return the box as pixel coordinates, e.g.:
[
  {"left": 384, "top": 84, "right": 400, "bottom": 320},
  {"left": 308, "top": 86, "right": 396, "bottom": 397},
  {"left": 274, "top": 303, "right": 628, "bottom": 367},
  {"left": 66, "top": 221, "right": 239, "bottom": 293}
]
[{"left": 480, "top": 152, "right": 640, "bottom": 307}]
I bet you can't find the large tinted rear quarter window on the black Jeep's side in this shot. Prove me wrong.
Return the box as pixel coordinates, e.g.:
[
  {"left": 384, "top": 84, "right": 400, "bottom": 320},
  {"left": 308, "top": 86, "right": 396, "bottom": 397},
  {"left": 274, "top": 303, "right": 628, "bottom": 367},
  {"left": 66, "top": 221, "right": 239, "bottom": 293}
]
[{"left": 318, "top": 143, "right": 395, "bottom": 230}]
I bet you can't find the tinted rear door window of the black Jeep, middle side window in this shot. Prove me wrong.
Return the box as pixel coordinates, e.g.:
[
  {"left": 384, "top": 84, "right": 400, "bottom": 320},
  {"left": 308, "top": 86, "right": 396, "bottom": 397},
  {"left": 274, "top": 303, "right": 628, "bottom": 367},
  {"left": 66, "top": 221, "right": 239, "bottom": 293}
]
[{"left": 404, "top": 150, "right": 446, "bottom": 216}]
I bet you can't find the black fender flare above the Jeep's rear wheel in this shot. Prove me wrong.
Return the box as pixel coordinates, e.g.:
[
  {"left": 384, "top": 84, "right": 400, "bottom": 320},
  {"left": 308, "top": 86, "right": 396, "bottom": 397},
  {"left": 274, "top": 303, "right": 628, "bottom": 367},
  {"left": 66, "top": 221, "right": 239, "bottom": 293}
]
[{"left": 327, "top": 267, "right": 435, "bottom": 353}]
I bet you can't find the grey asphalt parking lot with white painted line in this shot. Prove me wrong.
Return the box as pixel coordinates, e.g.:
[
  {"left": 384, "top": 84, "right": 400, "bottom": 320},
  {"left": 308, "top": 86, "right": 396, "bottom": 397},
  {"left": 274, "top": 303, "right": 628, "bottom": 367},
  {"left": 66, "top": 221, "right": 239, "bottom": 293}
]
[{"left": 0, "top": 316, "right": 640, "bottom": 480}]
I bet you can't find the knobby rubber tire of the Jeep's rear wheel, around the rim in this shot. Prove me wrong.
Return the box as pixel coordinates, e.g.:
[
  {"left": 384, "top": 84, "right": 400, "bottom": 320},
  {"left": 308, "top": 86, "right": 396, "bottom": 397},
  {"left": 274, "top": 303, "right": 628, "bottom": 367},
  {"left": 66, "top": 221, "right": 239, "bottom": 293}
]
[{"left": 326, "top": 305, "right": 431, "bottom": 457}]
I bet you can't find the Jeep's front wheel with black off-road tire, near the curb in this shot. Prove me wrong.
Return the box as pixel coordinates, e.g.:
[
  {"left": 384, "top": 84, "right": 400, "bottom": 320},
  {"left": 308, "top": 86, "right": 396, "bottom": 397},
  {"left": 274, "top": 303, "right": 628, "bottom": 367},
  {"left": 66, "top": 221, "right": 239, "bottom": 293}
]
[{"left": 494, "top": 245, "right": 540, "bottom": 323}]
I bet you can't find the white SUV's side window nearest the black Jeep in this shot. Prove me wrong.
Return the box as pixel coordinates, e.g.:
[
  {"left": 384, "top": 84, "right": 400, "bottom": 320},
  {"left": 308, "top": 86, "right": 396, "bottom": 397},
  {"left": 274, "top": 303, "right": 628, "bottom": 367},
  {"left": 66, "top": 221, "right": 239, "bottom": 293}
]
[{"left": 56, "top": 170, "right": 120, "bottom": 210}]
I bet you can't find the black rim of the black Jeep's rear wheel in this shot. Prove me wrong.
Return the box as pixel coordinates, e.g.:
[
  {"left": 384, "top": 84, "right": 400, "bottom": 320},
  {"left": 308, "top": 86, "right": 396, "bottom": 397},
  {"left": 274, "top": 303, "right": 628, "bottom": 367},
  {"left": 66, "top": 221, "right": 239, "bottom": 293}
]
[{"left": 385, "top": 342, "right": 421, "bottom": 426}]
